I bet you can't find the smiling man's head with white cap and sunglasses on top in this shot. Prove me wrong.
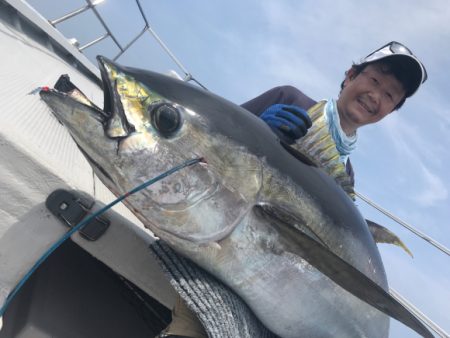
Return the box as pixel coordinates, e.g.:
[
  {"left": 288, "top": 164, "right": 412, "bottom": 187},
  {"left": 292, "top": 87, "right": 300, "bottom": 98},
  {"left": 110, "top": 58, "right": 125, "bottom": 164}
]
[{"left": 337, "top": 42, "right": 427, "bottom": 135}]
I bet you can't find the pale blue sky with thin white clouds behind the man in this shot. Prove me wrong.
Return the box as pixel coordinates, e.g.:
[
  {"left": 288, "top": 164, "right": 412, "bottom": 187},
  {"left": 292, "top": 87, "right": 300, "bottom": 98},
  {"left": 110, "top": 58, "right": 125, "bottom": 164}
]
[{"left": 28, "top": 0, "right": 450, "bottom": 338}]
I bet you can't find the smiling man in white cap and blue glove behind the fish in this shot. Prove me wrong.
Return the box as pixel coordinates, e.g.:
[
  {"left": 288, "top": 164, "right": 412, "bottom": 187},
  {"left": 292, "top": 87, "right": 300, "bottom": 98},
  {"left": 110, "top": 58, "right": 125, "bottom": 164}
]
[{"left": 159, "top": 41, "right": 427, "bottom": 338}]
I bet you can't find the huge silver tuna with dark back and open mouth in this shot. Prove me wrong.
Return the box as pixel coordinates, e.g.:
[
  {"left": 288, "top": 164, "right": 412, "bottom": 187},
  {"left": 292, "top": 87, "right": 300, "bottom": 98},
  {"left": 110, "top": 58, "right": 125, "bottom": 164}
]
[{"left": 41, "top": 57, "right": 432, "bottom": 338}]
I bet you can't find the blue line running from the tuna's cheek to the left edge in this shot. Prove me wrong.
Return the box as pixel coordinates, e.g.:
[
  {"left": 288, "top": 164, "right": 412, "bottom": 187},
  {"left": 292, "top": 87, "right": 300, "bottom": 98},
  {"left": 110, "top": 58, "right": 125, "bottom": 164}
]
[{"left": 0, "top": 158, "right": 203, "bottom": 318}]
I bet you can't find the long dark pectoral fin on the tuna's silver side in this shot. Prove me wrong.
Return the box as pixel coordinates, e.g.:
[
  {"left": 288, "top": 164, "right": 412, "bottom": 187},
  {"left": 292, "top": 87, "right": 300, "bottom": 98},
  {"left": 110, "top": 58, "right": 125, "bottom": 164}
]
[{"left": 255, "top": 205, "right": 433, "bottom": 338}]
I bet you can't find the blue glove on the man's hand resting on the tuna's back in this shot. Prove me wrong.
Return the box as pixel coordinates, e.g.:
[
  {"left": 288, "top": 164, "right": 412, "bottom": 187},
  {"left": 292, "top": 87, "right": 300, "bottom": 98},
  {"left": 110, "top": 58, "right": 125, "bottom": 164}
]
[{"left": 259, "top": 104, "right": 312, "bottom": 144}]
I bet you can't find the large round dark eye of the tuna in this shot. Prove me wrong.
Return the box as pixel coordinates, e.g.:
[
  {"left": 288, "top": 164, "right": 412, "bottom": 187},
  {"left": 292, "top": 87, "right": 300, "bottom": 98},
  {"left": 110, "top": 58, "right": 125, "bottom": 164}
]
[{"left": 148, "top": 102, "right": 183, "bottom": 137}]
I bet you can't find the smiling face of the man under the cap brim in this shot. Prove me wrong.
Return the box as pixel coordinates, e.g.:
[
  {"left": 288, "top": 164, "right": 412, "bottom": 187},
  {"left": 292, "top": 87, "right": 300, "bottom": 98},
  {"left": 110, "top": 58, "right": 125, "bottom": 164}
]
[{"left": 337, "top": 64, "right": 405, "bottom": 134}]
